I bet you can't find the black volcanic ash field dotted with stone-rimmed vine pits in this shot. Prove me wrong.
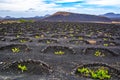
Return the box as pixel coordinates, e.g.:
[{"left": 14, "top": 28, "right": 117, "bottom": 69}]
[{"left": 0, "top": 22, "right": 120, "bottom": 80}]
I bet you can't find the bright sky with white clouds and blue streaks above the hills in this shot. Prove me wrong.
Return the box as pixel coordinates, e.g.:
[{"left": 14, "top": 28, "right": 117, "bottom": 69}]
[{"left": 0, "top": 0, "right": 120, "bottom": 17}]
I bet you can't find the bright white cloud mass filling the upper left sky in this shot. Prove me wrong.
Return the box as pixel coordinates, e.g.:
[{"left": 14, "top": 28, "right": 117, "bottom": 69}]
[{"left": 0, "top": 0, "right": 57, "bottom": 11}]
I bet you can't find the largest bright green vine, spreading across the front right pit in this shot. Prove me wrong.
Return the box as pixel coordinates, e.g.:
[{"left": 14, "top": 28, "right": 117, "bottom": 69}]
[{"left": 77, "top": 67, "right": 111, "bottom": 80}]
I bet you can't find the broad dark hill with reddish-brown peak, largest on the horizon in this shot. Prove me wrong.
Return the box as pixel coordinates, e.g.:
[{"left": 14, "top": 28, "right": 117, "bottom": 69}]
[{"left": 42, "top": 11, "right": 111, "bottom": 22}]
